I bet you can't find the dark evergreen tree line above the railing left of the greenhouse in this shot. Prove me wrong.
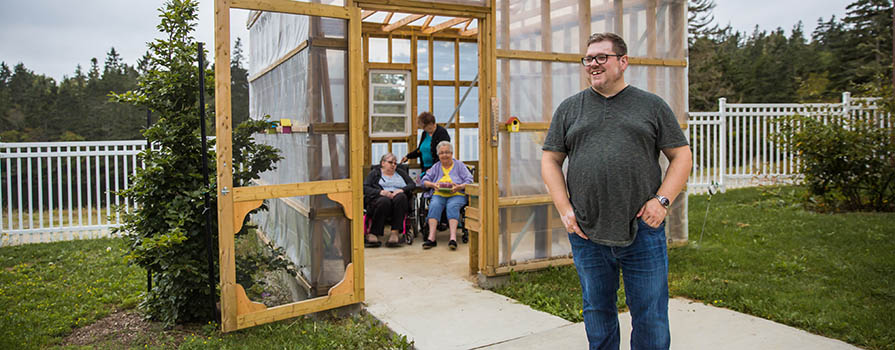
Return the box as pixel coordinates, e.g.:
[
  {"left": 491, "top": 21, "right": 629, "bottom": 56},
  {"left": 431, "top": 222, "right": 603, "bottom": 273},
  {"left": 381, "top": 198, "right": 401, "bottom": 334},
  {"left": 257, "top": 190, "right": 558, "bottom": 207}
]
[{"left": 0, "top": 38, "right": 249, "bottom": 142}]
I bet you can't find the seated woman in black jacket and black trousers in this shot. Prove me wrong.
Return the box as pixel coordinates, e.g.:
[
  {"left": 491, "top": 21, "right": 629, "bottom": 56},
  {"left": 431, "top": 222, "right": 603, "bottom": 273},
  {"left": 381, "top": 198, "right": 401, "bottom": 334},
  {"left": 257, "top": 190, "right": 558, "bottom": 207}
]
[{"left": 364, "top": 152, "right": 416, "bottom": 248}]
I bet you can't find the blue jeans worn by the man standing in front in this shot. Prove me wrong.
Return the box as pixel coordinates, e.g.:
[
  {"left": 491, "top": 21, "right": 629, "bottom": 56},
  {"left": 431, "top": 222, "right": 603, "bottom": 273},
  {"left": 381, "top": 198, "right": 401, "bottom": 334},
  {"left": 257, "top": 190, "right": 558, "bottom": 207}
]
[{"left": 569, "top": 219, "right": 671, "bottom": 350}]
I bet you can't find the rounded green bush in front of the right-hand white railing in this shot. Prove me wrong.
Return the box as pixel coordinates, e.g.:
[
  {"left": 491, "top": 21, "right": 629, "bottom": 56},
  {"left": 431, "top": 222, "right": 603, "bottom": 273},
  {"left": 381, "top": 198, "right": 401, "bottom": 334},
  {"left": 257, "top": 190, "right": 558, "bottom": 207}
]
[{"left": 775, "top": 90, "right": 895, "bottom": 212}]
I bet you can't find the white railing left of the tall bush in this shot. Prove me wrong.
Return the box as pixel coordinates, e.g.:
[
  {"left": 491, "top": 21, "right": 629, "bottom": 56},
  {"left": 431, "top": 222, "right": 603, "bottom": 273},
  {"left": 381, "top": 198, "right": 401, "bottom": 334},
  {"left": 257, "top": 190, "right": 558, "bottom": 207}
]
[{"left": 0, "top": 140, "right": 146, "bottom": 246}]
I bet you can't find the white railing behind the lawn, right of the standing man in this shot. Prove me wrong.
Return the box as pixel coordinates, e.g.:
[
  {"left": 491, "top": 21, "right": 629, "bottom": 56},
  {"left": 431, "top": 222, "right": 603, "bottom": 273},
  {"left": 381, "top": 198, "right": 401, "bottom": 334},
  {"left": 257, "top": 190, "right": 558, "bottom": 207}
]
[{"left": 687, "top": 92, "right": 892, "bottom": 193}]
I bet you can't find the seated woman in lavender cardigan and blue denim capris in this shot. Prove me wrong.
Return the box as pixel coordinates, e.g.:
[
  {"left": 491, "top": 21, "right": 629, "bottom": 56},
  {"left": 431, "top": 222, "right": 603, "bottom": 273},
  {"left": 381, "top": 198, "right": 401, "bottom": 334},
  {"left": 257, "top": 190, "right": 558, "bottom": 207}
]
[{"left": 422, "top": 141, "right": 472, "bottom": 250}]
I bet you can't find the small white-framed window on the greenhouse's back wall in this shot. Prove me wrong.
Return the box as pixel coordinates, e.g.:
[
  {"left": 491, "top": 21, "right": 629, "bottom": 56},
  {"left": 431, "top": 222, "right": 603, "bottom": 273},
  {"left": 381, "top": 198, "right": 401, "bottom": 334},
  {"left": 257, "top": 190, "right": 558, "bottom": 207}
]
[{"left": 370, "top": 70, "right": 410, "bottom": 137}]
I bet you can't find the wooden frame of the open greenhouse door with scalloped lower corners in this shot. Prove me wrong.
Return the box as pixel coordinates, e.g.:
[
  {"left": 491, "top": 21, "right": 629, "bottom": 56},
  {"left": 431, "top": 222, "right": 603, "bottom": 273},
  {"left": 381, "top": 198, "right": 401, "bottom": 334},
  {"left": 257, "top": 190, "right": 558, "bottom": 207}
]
[{"left": 215, "top": 0, "right": 364, "bottom": 332}]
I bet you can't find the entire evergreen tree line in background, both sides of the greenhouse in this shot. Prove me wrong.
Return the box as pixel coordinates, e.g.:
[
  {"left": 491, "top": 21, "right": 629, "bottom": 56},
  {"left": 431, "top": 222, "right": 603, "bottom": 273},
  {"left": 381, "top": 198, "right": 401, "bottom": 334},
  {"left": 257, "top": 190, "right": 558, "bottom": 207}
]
[{"left": 0, "top": 0, "right": 895, "bottom": 142}]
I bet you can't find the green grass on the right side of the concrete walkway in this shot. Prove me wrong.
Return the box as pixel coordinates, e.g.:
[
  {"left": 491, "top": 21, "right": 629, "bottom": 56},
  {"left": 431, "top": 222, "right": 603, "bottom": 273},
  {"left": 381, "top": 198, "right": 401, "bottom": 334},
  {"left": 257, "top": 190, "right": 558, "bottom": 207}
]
[{"left": 496, "top": 186, "right": 895, "bottom": 349}]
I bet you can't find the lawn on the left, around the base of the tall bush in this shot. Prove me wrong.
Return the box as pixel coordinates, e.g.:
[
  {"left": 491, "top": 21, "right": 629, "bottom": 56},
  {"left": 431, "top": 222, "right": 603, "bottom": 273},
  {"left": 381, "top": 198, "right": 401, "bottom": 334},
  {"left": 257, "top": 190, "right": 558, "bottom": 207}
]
[{"left": 0, "top": 239, "right": 411, "bottom": 349}]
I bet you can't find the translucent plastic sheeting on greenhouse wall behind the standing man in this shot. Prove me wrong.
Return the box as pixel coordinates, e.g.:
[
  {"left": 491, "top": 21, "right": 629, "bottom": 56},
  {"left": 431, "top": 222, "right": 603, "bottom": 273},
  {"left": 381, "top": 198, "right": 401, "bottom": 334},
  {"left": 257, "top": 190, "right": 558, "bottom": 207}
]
[{"left": 495, "top": 0, "right": 687, "bottom": 264}]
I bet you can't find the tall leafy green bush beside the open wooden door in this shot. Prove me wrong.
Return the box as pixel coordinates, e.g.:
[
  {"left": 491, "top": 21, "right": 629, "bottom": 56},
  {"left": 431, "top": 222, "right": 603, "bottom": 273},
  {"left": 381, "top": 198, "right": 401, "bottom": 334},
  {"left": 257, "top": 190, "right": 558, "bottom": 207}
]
[{"left": 113, "top": 0, "right": 280, "bottom": 326}]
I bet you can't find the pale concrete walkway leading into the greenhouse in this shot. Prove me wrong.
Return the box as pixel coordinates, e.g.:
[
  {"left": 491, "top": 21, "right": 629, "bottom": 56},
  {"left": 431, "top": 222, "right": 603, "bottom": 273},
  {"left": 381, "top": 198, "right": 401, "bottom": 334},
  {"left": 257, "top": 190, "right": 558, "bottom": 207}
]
[{"left": 365, "top": 232, "right": 858, "bottom": 350}]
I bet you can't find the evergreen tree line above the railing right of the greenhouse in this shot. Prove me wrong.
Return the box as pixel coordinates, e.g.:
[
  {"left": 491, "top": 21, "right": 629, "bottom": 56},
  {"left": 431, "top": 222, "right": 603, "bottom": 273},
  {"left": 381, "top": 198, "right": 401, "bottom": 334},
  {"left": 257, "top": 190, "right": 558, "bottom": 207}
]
[{"left": 688, "top": 0, "right": 895, "bottom": 111}]
